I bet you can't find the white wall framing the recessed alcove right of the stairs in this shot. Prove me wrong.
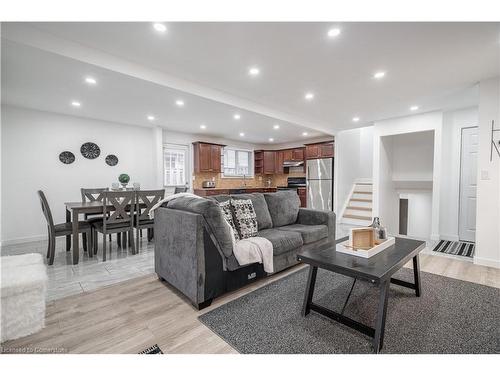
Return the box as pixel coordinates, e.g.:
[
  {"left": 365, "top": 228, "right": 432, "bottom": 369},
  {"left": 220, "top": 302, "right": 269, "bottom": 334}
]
[{"left": 373, "top": 112, "right": 443, "bottom": 240}]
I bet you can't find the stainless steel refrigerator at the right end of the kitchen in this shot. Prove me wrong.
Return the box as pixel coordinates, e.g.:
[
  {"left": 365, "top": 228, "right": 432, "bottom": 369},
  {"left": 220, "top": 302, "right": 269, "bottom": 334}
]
[{"left": 306, "top": 158, "right": 333, "bottom": 211}]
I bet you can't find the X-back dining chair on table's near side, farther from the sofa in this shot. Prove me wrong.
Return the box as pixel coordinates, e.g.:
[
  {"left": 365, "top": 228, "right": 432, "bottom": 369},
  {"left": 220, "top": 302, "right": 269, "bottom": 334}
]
[{"left": 92, "top": 191, "right": 135, "bottom": 261}]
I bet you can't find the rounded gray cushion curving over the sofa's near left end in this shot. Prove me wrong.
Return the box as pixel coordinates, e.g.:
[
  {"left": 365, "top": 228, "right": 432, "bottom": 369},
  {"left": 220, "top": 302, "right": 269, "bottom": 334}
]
[{"left": 166, "top": 197, "right": 234, "bottom": 257}]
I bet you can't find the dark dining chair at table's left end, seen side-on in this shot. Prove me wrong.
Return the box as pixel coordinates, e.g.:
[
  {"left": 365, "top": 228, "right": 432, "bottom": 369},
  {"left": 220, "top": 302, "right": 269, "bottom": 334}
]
[{"left": 38, "top": 190, "right": 92, "bottom": 265}]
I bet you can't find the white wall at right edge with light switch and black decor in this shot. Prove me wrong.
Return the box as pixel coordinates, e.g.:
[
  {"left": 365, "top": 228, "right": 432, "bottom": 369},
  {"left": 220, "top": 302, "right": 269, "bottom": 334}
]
[{"left": 474, "top": 77, "right": 500, "bottom": 268}]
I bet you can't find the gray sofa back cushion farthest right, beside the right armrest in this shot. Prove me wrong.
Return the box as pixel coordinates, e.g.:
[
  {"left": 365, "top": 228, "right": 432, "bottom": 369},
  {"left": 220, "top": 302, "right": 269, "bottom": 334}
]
[{"left": 264, "top": 190, "right": 300, "bottom": 228}]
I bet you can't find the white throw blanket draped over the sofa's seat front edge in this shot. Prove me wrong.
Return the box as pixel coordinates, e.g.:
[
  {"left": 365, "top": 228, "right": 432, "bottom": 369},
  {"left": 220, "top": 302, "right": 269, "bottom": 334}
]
[{"left": 233, "top": 237, "right": 274, "bottom": 273}]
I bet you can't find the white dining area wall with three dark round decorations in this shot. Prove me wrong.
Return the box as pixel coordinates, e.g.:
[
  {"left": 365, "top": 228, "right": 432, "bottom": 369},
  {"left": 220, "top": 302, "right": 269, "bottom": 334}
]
[{"left": 1, "top": 106, "right": 160, "bottom": 244}]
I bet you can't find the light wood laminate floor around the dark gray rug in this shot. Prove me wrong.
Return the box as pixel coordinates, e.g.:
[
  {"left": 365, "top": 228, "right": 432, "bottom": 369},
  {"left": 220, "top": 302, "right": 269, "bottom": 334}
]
[{"left": 2, "top": 253, "right": 500, "bottom": 353}]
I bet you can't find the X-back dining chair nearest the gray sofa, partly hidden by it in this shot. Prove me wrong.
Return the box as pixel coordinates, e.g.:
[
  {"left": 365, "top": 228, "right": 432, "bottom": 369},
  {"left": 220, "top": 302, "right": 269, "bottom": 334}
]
[{"left": 134, "top": 189, "right": 165, "bottom": 251}]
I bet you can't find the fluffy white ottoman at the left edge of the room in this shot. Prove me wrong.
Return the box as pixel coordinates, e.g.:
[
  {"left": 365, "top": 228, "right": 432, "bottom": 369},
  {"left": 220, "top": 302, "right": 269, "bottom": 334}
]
[{"left": 0, "top": 254, "right": 47, "bottom": 342}]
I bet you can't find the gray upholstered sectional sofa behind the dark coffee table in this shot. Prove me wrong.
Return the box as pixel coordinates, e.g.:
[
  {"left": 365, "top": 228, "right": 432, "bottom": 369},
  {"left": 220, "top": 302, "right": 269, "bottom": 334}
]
[{"left": 154, "top": 190, "right": 335, "bottom": 309}]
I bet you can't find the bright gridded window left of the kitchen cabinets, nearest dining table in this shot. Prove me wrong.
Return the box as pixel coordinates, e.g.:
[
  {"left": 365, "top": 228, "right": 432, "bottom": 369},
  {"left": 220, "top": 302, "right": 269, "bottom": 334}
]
[{"left": 163, "top": 144, "right": 188, "bottom": 186}]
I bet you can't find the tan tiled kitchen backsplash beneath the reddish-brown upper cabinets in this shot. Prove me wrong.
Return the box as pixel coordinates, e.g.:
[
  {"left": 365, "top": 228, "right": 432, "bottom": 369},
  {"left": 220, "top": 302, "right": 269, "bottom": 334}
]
[{"left": 193, "top": 172, "right": 305, "bottom": 189}]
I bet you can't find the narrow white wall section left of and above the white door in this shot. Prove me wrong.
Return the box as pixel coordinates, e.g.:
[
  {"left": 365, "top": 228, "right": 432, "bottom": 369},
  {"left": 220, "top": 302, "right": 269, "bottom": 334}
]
[{"left": 439, "top": 108, "right": 479, "bottom": 241}]
